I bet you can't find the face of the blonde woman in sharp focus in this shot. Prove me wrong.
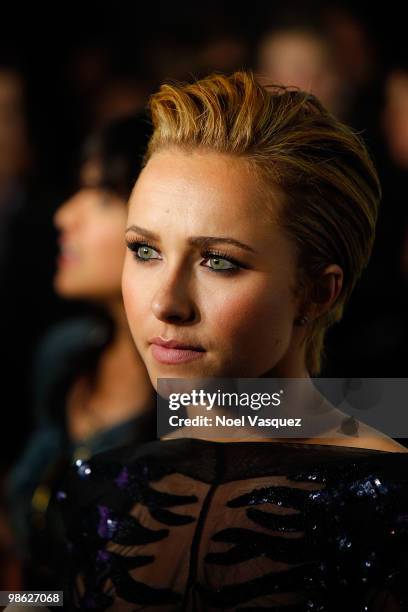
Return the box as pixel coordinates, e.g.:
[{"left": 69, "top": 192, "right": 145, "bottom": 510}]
[{"left": 122, "top": 149, "right": 299, "bottom": 384}]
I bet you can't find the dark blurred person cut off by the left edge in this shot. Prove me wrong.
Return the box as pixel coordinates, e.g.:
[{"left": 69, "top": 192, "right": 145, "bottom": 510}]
[{"left": 0, "top": 62, "right": 58, "bottom": 470}]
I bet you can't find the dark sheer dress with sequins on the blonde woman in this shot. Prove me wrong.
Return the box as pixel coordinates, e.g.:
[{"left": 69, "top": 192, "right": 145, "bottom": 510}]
[{"left": 58, "top": 439, "right": 408, "bottom": 612}]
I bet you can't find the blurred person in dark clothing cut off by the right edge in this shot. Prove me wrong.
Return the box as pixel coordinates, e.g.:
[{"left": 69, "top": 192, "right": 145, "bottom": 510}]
[{"left": 326, "top": 63, "right": 408, "bottom": 378}]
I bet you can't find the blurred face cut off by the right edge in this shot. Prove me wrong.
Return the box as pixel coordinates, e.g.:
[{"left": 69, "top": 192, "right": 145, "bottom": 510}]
[{"left": 383, "top": 71, "right": 408, "bottom": 169}]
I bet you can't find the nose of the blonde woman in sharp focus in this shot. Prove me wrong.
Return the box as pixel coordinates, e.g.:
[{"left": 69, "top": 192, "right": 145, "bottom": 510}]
[{"left": 152, "top": 272, "right": 198, "bottom": 324}]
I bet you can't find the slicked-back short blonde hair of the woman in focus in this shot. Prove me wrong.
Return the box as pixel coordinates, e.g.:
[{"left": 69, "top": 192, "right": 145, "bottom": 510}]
[{"left": 146, "top": 72, "right": 381, "bottom": 375}]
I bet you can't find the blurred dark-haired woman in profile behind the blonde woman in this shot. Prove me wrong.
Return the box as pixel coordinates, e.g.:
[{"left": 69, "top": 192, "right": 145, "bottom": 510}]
[{"left": 8, "top": 116, "right": 155, "bottom": 589}]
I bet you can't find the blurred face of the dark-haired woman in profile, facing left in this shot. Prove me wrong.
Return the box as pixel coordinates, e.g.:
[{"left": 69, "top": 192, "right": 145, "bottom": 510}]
[{"left": 54, "top": 162, "right": 127, "bottom": 303}]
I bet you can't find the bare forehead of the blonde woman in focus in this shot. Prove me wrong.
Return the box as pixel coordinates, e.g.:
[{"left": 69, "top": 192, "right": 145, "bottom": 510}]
[{"left": 130, "top": 149, "right": 280, "bottom": 226}]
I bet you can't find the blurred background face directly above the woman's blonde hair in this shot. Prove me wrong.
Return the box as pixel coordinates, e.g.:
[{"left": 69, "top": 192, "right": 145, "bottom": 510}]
[{"left": 257, "top": 25, "right": 346, "bottom": 116}]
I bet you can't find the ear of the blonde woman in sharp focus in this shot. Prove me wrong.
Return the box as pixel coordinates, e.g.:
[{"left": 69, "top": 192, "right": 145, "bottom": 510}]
[{"left": 307, "top": 264, "right": 344, "bottom": 321}]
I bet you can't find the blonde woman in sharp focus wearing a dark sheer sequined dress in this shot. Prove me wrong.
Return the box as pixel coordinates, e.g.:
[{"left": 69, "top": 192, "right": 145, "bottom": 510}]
[{"left": 61, "top": 72, "right": 408, "bottom": 612}]
